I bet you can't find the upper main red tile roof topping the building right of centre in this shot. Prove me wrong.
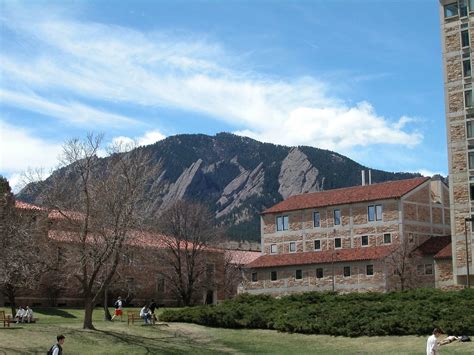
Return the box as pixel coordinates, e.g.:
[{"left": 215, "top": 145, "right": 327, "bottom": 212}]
[{"left": 262, "top": 177, "right": 430, "bottom": 214}]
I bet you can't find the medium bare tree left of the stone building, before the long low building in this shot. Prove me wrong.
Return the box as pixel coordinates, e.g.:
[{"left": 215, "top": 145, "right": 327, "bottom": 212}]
[{"left": 158, "top": 201, "right": 219, "bottom": 306}]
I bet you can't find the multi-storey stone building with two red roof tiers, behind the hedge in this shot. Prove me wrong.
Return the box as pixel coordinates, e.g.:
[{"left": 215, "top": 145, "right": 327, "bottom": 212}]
[{"left": 243, "top": 178, "right": 450, "bottom": 295}]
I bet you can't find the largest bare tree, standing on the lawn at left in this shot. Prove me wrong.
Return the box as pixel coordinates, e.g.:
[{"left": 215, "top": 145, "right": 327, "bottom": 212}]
[{"left": 45, "top": 134, "right": 151, "bottom": 329}]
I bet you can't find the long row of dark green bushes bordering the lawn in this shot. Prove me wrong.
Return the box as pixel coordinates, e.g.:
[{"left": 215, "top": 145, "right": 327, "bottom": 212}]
[{"left": 160, "top": 289, "right": 474, "bottom": 337}]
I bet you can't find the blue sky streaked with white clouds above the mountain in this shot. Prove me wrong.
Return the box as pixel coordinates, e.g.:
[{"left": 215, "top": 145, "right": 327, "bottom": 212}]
[{"left": 0, "top": 0, "right": 448, "bottom": 192}]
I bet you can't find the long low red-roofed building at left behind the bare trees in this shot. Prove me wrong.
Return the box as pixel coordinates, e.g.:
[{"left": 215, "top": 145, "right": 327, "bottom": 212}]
[{"left": 0, "top": 200, "right": 230, "bottom": 307}]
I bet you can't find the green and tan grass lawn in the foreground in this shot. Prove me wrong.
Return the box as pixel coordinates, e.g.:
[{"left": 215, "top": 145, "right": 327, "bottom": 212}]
[{"left": 0, "top": 308, "right": 474, "bottom": 355}]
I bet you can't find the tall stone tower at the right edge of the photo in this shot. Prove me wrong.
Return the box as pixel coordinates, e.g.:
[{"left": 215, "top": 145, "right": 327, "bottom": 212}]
[{"left": 440, "top": 0, "right": 474, "bottom": 285}]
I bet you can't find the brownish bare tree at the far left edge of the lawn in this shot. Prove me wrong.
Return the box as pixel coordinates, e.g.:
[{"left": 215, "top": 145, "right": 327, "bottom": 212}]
[{"left": 0, "top": 176, "right": 51, "bottom": 316}]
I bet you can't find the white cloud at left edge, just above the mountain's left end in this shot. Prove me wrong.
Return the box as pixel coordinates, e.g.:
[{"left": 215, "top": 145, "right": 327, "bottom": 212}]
[{"left": 0, "top": 120, "right": 62, "bottom": 191}]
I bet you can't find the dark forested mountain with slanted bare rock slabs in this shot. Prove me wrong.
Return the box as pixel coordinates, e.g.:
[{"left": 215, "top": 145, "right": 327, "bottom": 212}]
[{"left": 17, "top": 133, "right": 419, "bottom": 240}]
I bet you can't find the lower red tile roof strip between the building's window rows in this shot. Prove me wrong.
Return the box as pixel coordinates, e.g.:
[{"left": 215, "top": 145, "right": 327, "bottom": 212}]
[{"left": 247, "top": 246, "right": 393, "bottom": 268}]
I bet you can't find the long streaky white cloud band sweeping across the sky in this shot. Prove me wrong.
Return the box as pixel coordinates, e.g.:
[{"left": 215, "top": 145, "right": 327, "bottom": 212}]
[{"left": 2, "top": 9, "right": 423, "bottom": 152}]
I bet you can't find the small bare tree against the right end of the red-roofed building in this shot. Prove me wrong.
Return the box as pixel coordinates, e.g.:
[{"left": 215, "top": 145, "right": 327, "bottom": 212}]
[{"left": 385, "top": 238, "right": 420, "bottom": 291}]
